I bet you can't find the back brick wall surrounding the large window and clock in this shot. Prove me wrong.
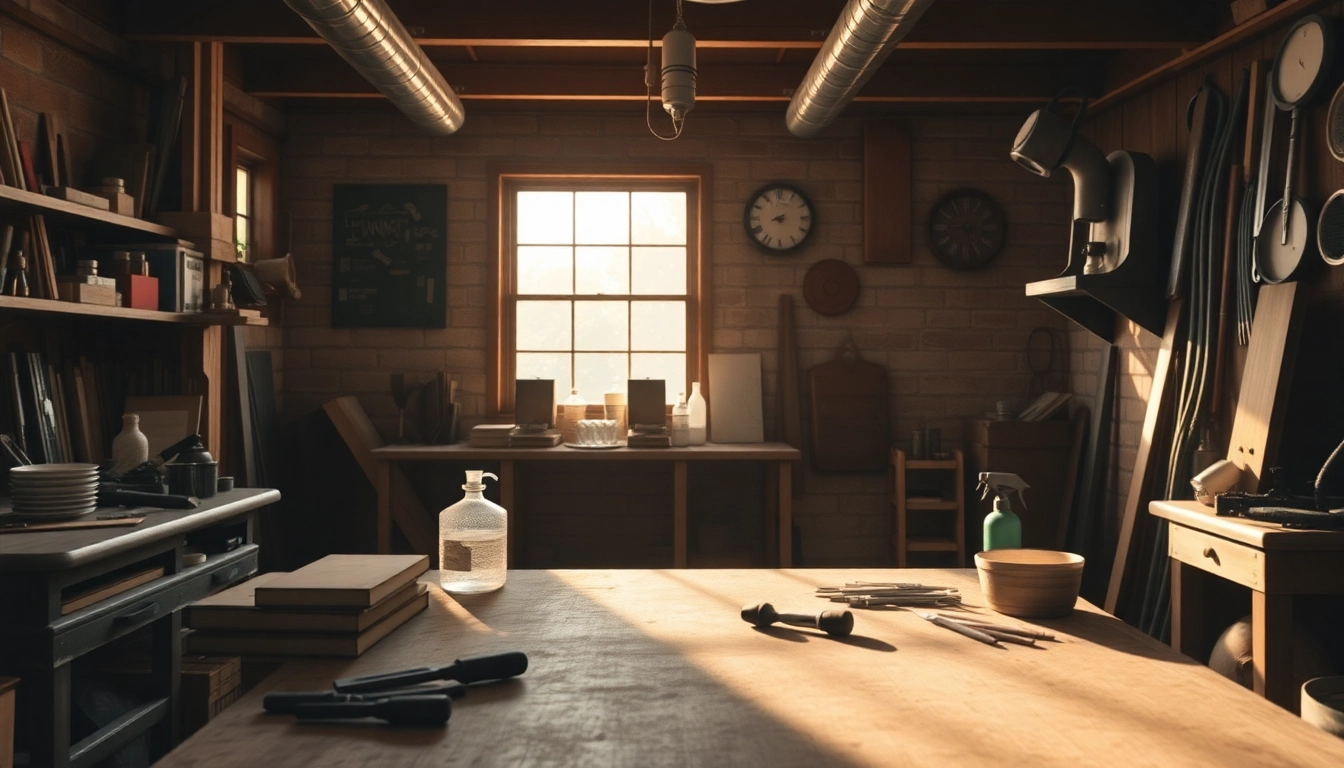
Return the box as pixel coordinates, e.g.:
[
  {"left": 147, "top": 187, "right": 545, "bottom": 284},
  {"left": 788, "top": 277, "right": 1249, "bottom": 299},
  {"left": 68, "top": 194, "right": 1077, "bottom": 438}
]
[{"left": 282, "top": 105, "right": 1070, "bottom": 565}]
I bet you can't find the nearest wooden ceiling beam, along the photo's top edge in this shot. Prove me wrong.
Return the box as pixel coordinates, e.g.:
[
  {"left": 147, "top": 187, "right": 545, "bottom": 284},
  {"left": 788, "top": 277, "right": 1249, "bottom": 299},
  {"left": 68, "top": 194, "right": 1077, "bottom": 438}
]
[{"left": 125, "top": 0, "right": 1212, "bottom": 50}]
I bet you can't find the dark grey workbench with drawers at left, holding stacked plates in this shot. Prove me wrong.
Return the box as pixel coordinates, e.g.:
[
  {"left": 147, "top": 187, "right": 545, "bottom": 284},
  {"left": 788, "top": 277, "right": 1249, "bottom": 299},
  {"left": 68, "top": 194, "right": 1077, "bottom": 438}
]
[{"left": 0, "top": 488, "right": 280, "bottom": 768}]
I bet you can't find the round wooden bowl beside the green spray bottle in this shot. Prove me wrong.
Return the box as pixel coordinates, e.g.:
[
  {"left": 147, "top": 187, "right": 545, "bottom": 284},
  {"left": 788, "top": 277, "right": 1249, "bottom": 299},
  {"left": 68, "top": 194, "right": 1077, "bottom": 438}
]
[{"left": 976, "top": 549, "right": 1083, "bottom": 619}]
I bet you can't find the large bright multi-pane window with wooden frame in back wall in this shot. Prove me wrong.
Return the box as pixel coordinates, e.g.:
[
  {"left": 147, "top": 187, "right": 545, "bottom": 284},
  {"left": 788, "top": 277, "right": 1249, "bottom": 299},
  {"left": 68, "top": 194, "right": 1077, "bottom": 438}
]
[{"left": 496, "top": 169, "right": 707, "bottom": 410}]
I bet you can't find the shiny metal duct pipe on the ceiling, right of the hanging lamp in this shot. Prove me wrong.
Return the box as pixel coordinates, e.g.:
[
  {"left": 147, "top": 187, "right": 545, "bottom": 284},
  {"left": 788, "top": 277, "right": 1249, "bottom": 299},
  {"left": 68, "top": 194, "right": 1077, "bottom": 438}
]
[{"left": 784, "top": 0, "right": 933, "bottom": 139}]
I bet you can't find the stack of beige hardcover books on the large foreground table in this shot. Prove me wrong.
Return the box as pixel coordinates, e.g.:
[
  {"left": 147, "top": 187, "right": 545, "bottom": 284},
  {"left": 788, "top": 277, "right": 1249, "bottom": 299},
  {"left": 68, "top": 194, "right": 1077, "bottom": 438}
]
[{"left": 183, "top": 554, "right": 429, "bottom": 656}]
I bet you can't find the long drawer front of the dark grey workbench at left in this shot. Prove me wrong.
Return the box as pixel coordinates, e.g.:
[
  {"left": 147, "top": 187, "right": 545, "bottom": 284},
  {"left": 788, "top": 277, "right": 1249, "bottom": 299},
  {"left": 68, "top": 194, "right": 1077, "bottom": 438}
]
[{"left": 50, "top": 545, "right": 259, "bottom": 664}]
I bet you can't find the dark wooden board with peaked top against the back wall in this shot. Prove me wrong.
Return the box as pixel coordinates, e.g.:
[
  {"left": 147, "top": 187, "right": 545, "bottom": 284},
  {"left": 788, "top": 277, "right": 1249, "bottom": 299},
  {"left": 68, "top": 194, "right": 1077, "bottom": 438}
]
[{"left": 808, "top": 336, "right": 891, "bottom": 472}]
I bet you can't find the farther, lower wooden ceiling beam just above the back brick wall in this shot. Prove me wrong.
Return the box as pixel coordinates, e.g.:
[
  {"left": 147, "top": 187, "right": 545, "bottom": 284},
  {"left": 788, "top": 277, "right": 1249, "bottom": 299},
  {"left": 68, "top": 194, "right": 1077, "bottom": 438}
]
[{"left": 243, "top": 56, "right": 1101, "bottom": 104}]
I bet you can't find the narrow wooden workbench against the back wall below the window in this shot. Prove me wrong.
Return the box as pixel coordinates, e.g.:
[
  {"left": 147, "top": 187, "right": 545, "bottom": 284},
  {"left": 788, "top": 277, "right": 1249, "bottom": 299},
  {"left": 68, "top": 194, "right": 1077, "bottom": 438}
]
[{"left": 371, "top": 443, "right": 802, "bottom": 568}]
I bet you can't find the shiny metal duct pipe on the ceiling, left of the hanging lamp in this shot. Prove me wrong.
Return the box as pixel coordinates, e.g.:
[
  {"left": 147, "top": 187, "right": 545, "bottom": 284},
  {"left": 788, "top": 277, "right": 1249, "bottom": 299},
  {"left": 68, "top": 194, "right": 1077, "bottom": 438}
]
[{"left": 285, "top": 0, "right": 466, "bottom": 135}]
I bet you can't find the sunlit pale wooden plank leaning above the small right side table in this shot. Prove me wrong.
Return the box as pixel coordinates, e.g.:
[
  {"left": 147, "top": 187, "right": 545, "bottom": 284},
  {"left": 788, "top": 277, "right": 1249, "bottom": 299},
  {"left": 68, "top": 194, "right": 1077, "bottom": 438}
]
[{"left": 1227, "top": 282, "right": 1304, "bottom": 492}]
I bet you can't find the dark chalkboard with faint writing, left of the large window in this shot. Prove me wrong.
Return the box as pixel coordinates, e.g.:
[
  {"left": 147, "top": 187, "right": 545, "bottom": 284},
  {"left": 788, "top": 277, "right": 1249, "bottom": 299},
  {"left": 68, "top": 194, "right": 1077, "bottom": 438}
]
[{"left": 332, "top": 184, "right": 448, "bottom": 328}]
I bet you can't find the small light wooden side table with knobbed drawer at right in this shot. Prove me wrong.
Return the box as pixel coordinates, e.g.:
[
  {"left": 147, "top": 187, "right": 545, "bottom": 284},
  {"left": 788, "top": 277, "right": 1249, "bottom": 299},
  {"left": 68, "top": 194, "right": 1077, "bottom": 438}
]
[{"left": 1148, "top": 502, "right": 1344, "bottom": 713}]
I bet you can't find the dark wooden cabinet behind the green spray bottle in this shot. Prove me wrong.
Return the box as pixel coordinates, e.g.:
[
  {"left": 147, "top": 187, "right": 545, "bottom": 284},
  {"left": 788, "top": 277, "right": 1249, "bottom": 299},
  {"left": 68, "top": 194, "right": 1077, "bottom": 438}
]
[{"left": 966, "top": 418, "right": 1074, "bottom": 549}]
